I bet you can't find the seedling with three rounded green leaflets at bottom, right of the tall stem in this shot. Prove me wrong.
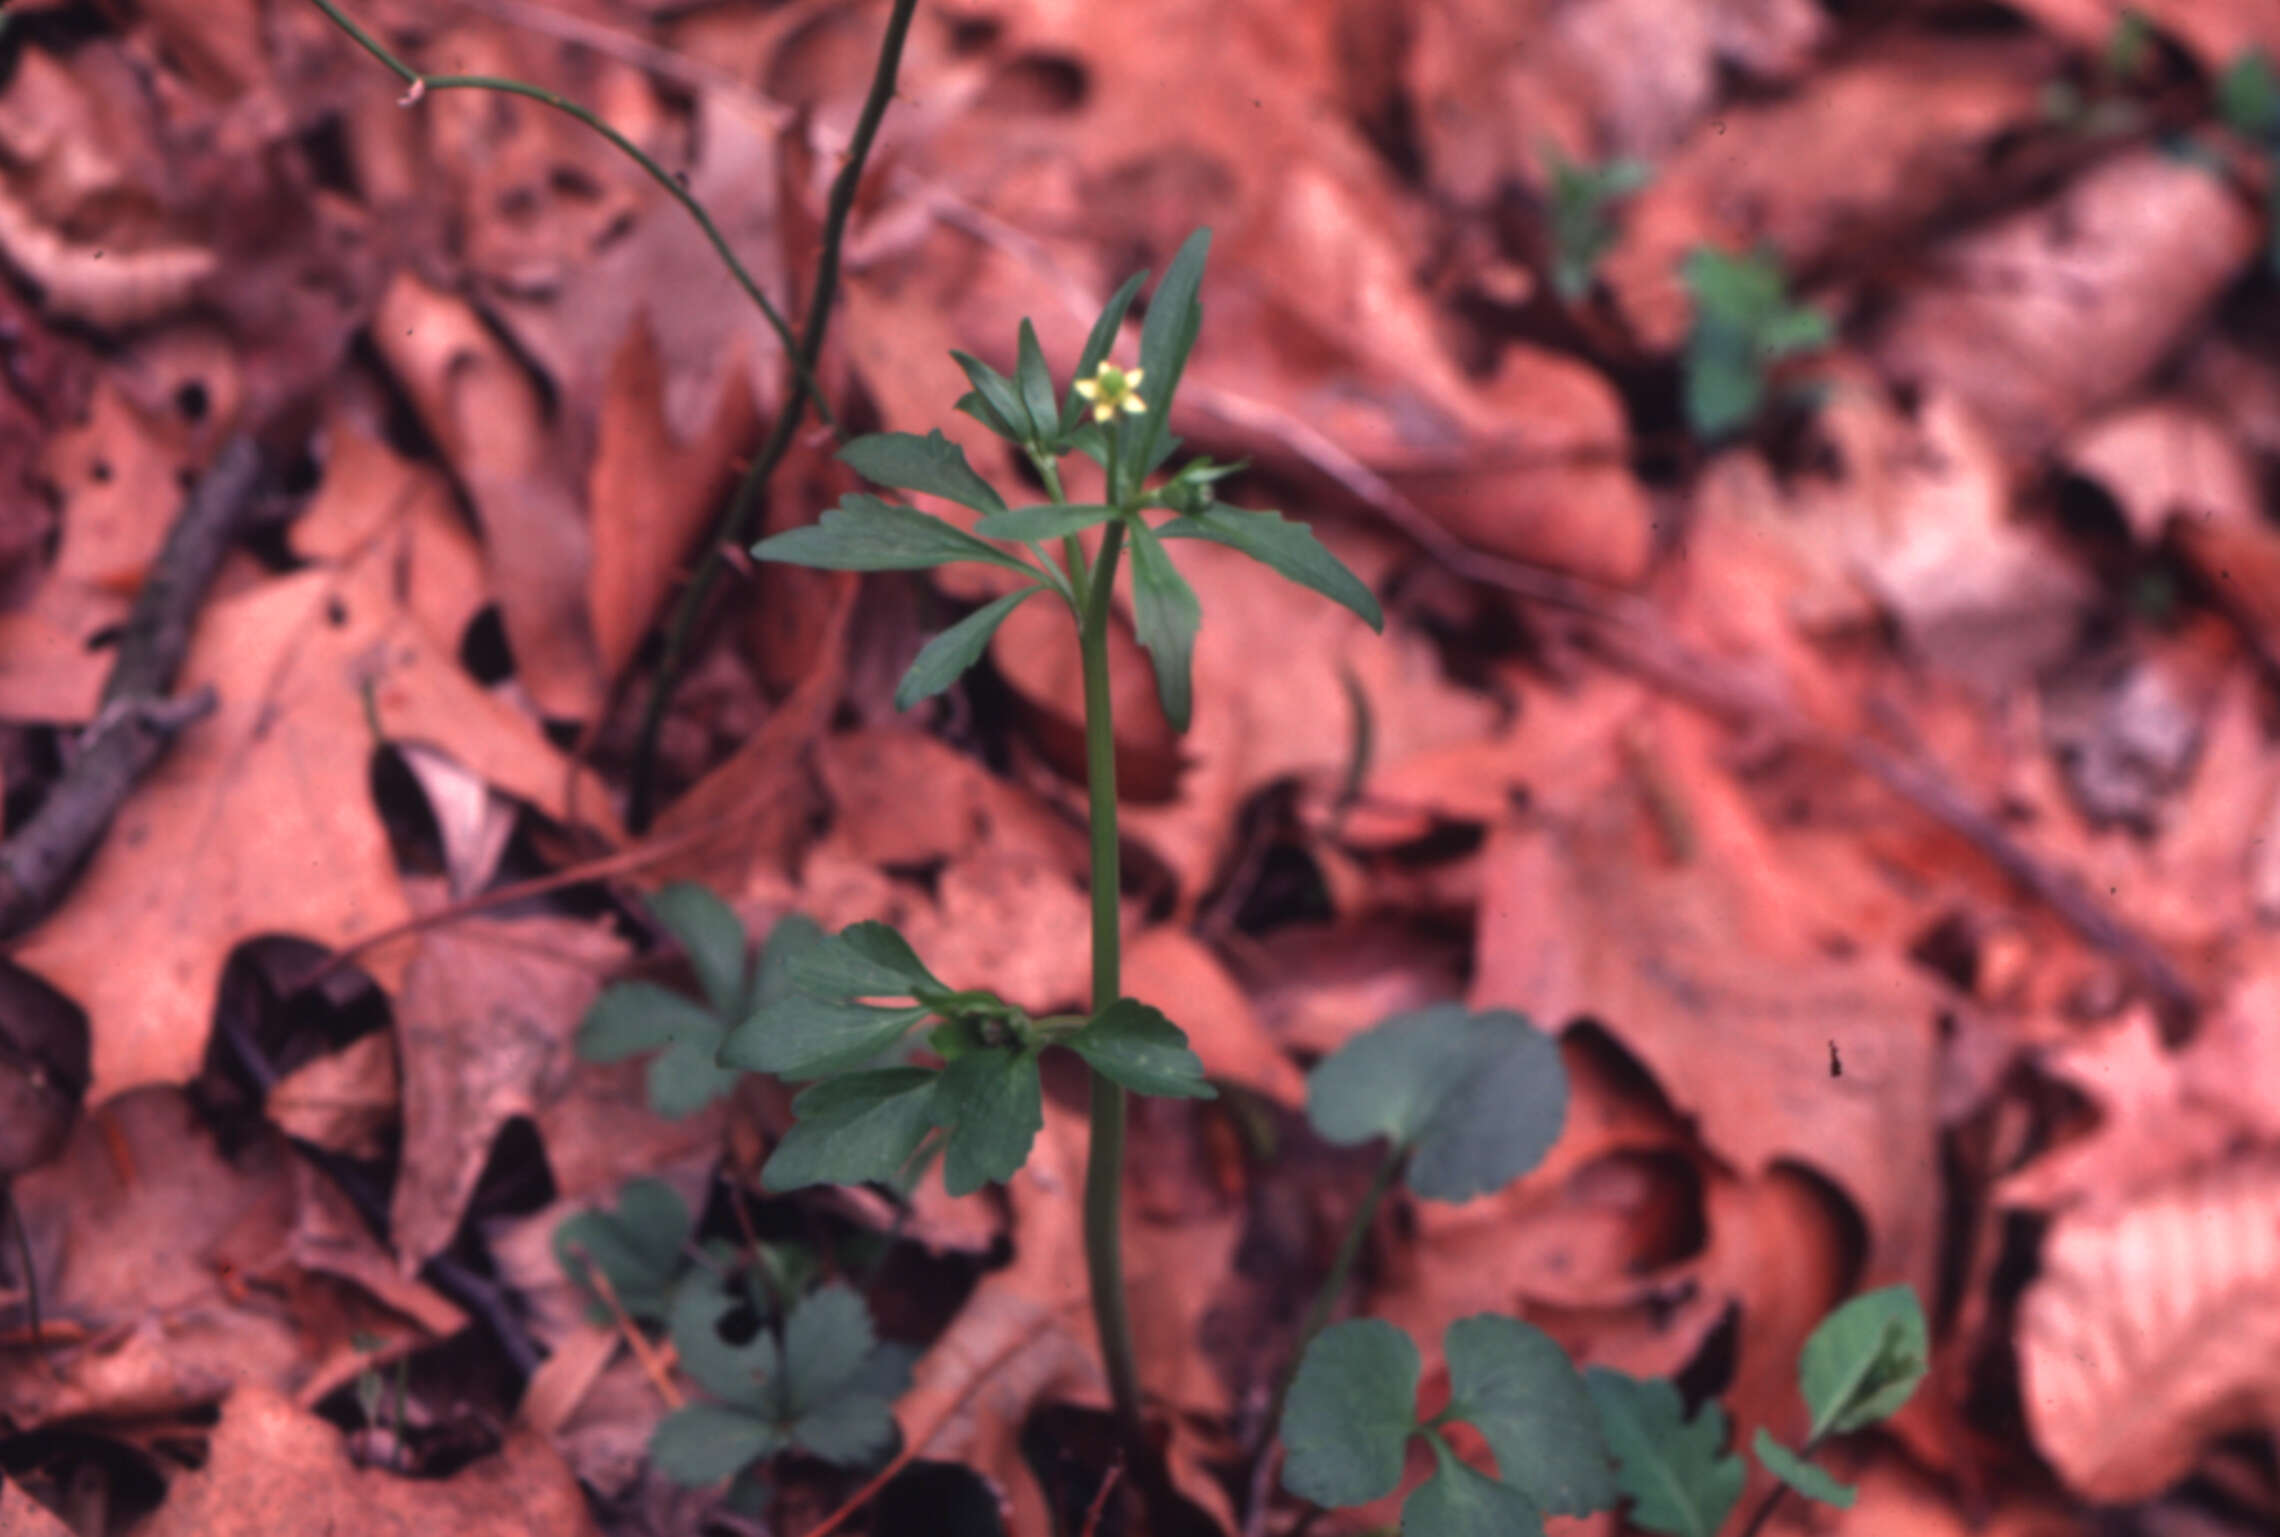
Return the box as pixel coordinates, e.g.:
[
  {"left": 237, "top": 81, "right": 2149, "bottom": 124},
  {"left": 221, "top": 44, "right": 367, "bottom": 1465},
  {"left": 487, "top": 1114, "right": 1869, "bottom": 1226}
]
[{"left": 1284, "top": 1314, "right": 1614, "bottom": 1537}]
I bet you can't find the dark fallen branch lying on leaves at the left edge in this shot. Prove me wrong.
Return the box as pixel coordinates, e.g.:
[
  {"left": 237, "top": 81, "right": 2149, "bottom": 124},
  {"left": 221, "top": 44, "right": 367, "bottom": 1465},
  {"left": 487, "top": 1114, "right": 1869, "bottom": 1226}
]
[{"left": 0, "top": 433, "right": 262, "bottom": 940}]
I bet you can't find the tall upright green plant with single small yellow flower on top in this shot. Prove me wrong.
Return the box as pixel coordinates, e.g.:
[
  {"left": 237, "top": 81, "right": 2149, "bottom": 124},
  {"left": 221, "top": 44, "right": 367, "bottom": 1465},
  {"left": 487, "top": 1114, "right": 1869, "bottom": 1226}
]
[{"left": 738, "top": 230, "right": 1384, "bottom": 1457}]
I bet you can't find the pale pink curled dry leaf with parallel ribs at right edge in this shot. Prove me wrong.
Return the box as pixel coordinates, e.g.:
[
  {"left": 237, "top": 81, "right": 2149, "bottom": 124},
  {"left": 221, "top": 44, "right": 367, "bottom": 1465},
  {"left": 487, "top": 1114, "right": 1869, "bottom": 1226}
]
[{"left": 2018, "top": 1156, "right": 2280, "bottom": 1505}]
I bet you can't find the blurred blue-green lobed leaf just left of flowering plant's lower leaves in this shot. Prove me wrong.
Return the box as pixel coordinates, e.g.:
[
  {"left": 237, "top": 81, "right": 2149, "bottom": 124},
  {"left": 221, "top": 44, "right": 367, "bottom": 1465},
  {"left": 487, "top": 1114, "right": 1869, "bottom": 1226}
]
[{"left": 577, "top": 883, "right": 821, "bottom": 1120}]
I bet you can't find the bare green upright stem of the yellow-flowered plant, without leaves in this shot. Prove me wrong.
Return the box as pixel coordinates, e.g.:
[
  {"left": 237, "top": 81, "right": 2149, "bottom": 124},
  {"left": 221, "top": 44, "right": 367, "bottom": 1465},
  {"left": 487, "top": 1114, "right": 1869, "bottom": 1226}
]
[{"left": 1076, "top": 522, "right": 1147, "bottom": 1459}]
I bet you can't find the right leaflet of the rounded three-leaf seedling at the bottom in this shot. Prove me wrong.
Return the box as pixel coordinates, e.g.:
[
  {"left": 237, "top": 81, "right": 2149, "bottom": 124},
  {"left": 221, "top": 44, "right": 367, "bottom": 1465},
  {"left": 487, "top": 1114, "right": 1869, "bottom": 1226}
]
[{"left": 1446, "top": 1314, "right": 1614, "bottom": 1516}]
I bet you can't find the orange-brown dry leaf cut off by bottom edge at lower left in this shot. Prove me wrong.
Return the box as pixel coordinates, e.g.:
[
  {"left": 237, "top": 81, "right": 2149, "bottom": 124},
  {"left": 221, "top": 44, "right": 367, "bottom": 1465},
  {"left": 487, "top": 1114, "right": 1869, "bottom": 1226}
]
[{"left": 144, "top": 1386, "right": 597, "bottom": 1537}]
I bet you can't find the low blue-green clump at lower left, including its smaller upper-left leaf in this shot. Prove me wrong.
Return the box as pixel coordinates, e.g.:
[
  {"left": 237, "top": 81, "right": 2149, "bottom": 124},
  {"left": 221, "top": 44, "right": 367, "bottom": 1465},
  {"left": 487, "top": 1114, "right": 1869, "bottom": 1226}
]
[{"left": 554, "top": 1179, "right": 912, "bottom": 1507}]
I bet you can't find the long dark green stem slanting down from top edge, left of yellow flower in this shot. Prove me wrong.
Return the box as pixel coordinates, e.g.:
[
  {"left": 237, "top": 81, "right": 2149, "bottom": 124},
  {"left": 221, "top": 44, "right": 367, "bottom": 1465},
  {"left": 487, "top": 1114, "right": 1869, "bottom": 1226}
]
[{"left": 624, "top": 0, "right": 919, "bottom": 832}]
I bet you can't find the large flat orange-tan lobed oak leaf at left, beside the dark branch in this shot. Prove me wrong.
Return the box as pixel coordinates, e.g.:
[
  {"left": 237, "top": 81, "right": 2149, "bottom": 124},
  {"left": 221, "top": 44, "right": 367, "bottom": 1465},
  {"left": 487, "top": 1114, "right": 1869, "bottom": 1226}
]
[{"left": 16, "top": 559, "right": 604, "bottom": 1101}]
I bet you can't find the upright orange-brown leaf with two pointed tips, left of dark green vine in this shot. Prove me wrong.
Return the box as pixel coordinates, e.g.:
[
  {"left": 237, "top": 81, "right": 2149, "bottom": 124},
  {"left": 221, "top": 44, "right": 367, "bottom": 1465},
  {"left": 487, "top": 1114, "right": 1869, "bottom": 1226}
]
[{"left": 586, "top": 315, "right": 755, "bottom": 677}]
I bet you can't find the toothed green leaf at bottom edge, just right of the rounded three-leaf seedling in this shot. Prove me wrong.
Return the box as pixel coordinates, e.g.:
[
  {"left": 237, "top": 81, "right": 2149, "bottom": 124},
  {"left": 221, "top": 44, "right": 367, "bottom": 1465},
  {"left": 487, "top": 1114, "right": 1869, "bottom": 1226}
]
[{"left": 1585, "top": 1366, "right": 1749, "bottom": 1537}]
